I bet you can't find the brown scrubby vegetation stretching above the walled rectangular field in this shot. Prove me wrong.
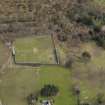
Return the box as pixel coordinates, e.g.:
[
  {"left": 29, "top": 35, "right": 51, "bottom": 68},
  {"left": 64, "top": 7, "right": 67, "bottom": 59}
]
[{"left": 0, "top": 0, "right": 105, "bottom": 44}]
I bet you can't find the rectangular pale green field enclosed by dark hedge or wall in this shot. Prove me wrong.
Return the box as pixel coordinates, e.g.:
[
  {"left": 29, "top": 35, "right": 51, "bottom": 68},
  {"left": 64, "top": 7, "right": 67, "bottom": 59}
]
[{"left": 14, "top": 36, "right": 56, "bottom": 64}]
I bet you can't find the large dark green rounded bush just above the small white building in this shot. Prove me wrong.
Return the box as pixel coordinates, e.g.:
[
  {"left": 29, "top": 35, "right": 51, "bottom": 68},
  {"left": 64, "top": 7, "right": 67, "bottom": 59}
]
[{"left": 40, "top": 85, "right": 59, "bottom": 97}]
